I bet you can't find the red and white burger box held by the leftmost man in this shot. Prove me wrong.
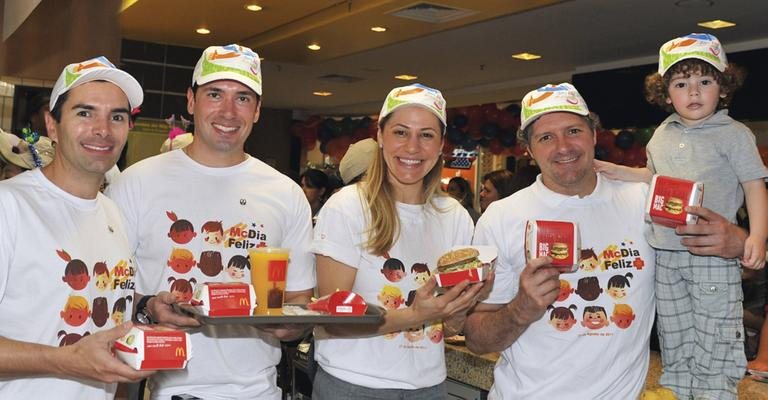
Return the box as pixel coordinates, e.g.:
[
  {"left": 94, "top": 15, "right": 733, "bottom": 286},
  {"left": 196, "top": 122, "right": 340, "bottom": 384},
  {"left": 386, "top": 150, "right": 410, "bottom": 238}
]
[{"left": 113, "top": 325, "right": 192, "bottom": 370}]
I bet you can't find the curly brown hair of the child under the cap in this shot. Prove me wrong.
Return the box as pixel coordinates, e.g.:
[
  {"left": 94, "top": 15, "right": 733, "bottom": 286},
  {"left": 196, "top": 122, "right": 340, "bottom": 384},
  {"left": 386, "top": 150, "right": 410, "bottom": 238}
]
[{"left": 645, "top": 58, "right": 747, "bottom": 112}]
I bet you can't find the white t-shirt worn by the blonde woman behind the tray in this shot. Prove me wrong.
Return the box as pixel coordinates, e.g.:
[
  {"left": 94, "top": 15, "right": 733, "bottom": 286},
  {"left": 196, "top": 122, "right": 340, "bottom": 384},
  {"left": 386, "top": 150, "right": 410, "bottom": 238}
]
[{"left": 312, "top": 185, "right": 472, "bottom": 389}]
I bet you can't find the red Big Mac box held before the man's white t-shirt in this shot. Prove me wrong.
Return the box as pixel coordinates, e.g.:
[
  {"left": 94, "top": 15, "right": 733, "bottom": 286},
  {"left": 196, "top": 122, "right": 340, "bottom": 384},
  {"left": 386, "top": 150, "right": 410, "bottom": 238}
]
[{"left": 525, "top": 220, "right": 581, "bottom": 272}]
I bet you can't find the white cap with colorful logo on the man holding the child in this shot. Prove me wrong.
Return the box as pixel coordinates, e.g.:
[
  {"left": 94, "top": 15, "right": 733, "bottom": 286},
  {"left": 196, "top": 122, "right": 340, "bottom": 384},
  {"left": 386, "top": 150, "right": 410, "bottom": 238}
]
[{"left": 520, "top": 83, "right": 589, "bottom": 130}]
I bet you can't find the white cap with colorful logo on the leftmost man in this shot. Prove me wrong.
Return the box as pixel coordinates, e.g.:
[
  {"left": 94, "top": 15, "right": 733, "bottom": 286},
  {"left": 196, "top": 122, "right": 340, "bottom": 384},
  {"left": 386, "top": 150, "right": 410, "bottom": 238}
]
[{"left": 49, "top": 56, "right": 144, "bottom": 110}]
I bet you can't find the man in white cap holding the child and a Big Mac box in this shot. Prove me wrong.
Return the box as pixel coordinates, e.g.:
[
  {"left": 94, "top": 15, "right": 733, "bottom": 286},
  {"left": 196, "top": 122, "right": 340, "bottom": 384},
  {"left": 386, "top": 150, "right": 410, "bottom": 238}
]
[{"left": 465, "top": 83, "right": 745, "bottom": 400}]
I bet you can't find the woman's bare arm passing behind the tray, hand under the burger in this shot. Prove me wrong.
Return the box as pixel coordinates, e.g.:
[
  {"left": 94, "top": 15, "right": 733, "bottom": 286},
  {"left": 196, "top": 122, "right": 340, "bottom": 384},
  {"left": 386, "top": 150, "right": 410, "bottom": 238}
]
[{"left": 316, "top": 255, "right": 483, "bottom": 337}]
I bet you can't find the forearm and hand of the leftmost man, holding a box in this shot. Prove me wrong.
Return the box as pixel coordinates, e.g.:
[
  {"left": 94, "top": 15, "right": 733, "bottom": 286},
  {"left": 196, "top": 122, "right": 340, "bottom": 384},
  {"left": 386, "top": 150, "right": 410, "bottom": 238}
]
[{"left": 0, "top": 323, "right": 154, "bottom": 383}]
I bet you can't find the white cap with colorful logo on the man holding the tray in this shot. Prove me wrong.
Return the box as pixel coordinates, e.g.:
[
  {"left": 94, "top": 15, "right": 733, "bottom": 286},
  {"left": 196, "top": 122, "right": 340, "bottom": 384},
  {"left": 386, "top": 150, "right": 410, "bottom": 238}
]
[{"left": 192, "top": 44, "right": 261, "bottom": 95}]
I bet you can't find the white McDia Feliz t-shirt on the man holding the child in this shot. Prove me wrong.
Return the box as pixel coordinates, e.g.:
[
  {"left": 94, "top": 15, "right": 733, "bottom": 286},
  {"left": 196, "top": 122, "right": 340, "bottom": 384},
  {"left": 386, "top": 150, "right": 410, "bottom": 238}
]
[{"left": 474, "top": 176, "right": 654, "bottom": 400}]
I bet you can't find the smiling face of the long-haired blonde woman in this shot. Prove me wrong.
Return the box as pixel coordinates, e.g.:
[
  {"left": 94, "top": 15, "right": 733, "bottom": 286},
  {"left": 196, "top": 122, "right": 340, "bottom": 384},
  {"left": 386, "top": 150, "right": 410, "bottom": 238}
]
[{"left": 378, "top": 106, "right": 443, "bottom": 201}]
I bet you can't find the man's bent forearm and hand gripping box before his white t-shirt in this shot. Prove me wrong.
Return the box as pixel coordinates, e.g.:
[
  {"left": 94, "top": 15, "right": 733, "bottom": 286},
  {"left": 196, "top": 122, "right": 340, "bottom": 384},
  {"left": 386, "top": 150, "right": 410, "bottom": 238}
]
[{"left": 464, "top": 257, "right": 560, "bottom": 354}]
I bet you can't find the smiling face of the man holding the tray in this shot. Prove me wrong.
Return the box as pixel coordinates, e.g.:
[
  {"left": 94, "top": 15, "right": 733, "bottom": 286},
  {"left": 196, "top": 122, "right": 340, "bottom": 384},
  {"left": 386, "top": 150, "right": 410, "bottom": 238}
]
[{"left": 186, "top": 80, "right": 260, "bottom": 167}]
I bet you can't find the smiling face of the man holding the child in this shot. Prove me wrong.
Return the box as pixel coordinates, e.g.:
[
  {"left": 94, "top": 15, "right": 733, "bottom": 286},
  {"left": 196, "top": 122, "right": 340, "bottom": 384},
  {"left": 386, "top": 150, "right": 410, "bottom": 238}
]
[{"left": 529, "top": 112, "right": 597, "bottom": 197}]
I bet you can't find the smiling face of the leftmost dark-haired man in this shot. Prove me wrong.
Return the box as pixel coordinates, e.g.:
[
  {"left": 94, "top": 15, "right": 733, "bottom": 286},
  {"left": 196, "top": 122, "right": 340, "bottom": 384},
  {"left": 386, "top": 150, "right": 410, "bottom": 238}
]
[{"left": 45, "top": 81, "right": 130, "bottom": 184}]
